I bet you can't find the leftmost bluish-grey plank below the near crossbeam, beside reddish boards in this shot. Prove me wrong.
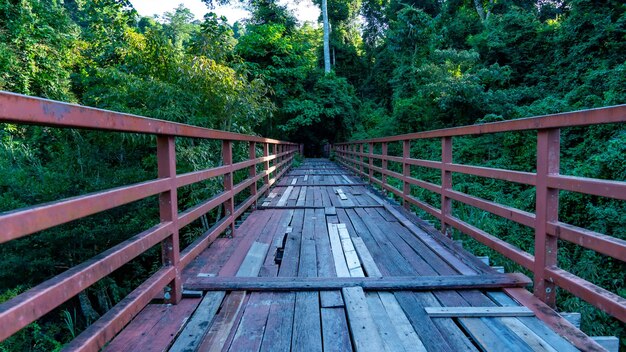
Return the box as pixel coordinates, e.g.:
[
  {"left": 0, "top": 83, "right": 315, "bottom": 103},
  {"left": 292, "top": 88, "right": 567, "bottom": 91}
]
[{"left": 169, "top": 291, "right": 226, "bottom": 352}]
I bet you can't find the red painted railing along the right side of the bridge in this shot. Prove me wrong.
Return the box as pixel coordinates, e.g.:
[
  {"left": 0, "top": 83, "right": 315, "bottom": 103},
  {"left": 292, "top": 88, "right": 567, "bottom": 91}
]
[{"left": 333, "top": 105, "right": 626, "bottom": 321}]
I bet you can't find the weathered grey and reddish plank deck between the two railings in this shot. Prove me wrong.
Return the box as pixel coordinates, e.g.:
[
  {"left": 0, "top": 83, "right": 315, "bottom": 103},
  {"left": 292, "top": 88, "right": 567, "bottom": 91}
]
[{"left": 107, "top": 159, "right": 577, "bottom": 351}]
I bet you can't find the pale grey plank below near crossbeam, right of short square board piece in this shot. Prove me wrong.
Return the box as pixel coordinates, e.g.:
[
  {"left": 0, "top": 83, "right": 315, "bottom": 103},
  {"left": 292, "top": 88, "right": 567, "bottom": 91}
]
[{"left": 341, "top": 287, "right": 385, "bottom": 351}]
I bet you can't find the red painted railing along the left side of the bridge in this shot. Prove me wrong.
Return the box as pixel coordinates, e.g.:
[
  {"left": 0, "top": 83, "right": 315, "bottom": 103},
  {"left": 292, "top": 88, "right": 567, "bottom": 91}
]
[{"left": 0, "top": 92, "right": 299, "bottom": 351}]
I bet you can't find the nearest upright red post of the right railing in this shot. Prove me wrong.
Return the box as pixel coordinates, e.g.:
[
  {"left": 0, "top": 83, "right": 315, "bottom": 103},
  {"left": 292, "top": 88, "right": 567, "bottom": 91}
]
[{"left": 534, "top": 128, "right": 561, "bottom": 307}]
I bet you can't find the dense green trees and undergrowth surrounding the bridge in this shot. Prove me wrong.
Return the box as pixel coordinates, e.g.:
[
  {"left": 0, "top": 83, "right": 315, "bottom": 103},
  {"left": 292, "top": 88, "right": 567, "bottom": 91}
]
[{"left": 0, "top": 0, "right": 626, "bottom": 351}]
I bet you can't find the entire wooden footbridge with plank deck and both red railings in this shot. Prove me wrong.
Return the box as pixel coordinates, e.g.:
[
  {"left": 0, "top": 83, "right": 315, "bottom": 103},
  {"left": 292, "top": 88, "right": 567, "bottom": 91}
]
[{"left": 0, "top": 93, "right": 626, "bottom": 351}]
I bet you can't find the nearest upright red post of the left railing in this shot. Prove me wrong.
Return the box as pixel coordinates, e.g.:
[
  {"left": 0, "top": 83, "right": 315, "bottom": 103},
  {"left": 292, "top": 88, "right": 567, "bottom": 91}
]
[{"left": 157, "top": 136, "right": 183, "bottom": 304}]
